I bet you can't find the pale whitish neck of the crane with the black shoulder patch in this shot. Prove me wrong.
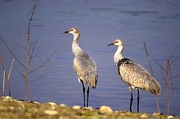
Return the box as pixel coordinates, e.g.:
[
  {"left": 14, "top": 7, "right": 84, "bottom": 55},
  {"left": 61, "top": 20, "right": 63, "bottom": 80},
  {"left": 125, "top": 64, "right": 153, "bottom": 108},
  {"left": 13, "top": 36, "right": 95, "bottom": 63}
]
[{"left": 114, "top": 46, "right": 124, "bottom": 66}]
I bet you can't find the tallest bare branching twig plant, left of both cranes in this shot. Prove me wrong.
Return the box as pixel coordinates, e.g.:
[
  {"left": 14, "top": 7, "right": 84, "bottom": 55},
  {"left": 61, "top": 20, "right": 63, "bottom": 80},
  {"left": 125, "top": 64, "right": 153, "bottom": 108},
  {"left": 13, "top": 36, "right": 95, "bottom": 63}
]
[{"left": 0, "top": 4, "right": 64, "bottom": 100}]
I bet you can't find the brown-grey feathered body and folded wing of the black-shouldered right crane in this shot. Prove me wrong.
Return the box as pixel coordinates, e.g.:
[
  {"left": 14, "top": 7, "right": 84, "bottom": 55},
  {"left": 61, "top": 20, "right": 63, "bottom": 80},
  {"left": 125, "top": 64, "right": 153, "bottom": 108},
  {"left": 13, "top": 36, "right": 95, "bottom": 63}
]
[{"left": 118, "top": 58, "right": 160, "bottom": 95}]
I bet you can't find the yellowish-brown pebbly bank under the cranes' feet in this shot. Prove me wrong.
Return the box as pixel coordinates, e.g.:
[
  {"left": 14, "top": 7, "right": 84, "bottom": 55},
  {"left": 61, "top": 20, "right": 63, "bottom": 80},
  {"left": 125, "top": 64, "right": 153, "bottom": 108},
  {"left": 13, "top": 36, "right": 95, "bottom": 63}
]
[{"left": 0, "top": 96, "right": 180, "bottom": 119}]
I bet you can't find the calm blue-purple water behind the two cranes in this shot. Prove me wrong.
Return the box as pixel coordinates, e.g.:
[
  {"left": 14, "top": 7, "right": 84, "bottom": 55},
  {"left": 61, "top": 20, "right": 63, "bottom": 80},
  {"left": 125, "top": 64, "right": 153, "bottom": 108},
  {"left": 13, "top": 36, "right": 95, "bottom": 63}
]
[{"left": 0, "top": 0, "right": 180, "bottom": 115}]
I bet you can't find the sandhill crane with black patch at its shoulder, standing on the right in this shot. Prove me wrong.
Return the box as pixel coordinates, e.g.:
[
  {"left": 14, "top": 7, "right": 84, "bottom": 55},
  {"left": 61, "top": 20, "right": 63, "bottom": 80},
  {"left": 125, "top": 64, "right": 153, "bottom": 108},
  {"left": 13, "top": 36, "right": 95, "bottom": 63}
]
[{"left": 108, "top": 39, "right": 161, "bottom": 112}]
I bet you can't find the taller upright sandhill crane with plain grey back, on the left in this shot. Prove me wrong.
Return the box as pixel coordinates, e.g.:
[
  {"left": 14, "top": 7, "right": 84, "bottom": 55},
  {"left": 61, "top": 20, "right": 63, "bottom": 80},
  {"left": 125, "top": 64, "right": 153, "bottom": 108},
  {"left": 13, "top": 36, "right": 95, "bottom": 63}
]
[{"left": 63, "top": 28, "right": 98, "bottom": 107}]
